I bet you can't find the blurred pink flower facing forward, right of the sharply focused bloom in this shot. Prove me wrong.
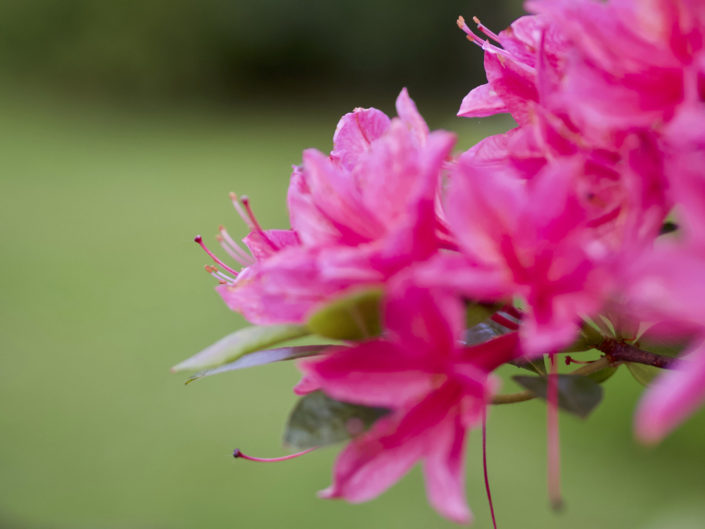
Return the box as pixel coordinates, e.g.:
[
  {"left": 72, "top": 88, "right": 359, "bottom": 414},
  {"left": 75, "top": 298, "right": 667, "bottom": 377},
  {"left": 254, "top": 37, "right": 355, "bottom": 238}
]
[{"left": 417, "top": 157, "right": 613, "bottom": 355}]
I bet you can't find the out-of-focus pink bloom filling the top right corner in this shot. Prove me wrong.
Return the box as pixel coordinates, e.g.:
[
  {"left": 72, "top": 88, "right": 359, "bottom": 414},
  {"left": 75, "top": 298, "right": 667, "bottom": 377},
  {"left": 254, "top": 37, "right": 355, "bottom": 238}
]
[{"left": 528, "top": 0, "right": 705, "bottom": 130}]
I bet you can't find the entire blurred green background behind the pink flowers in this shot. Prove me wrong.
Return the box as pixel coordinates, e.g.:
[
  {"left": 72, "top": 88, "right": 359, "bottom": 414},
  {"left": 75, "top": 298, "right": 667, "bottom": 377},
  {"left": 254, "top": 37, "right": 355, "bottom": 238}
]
[{"left": 0, "top": 0, "right": 705, "bottom": 529}]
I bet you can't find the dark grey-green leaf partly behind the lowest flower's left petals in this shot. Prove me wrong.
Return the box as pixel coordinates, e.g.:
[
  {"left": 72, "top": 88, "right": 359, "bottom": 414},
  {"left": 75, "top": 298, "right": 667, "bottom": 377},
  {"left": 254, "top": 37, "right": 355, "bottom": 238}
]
[{"left": 284, "top": 391, "right": 389, "bottom": 450}]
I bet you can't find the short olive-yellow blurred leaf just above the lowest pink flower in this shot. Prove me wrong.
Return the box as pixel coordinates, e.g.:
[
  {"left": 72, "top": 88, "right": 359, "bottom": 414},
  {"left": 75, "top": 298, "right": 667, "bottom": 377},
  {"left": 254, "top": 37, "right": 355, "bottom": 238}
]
[{"left": 307, "top": 288, "right": 382, "bottom": 340}]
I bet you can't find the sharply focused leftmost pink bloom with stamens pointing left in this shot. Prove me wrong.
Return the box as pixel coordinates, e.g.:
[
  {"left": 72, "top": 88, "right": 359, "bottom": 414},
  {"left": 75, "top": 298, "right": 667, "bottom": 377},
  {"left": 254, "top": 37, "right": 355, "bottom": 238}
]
[{"left": 201, "top": 90, "right": 455, "bottom": 324}]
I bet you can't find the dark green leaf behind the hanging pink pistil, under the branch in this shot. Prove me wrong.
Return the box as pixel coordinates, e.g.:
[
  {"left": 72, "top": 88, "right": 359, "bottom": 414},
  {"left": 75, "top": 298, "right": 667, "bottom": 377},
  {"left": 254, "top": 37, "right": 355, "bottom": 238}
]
[{"left": 512, "top": 375, "right": 602, "bottom": 419}]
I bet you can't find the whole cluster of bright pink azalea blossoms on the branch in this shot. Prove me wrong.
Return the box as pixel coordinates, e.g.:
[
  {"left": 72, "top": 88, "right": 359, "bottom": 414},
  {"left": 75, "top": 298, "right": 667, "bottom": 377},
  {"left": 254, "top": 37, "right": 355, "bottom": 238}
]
[{"left": 177, "top": 0, "right": 705, "bottom": 522}]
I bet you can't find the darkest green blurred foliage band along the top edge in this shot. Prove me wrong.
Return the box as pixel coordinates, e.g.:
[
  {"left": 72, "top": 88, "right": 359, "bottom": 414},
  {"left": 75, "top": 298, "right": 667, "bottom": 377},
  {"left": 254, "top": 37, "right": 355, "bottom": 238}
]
[{"left": 0, "top": 0, "right": 520, "bottom": 97}]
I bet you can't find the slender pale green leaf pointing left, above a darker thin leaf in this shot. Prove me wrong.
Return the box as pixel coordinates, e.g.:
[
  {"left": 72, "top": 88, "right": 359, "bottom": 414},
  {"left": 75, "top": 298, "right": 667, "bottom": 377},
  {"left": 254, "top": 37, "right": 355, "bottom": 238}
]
[{"left": 171, "top": 325, "right": 310, "bottom": 373}]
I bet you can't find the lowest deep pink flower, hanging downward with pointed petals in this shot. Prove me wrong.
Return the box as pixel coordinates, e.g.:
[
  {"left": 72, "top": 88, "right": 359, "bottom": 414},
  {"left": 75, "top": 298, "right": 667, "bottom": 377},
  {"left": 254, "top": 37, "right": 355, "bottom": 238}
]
[{"left": 302, "top": 285, "right": 518, "bottom": 523}]
